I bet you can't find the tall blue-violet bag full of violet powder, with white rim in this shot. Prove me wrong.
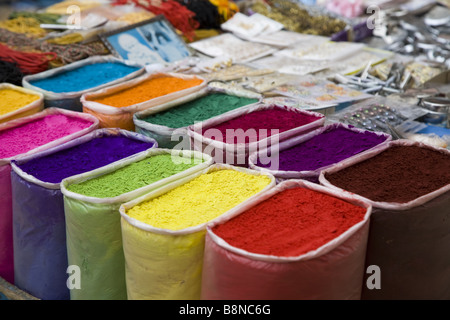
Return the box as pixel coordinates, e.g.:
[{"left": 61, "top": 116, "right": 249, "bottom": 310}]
[{"left": 11, "top": 129, "right": 157, "bottom": 300}]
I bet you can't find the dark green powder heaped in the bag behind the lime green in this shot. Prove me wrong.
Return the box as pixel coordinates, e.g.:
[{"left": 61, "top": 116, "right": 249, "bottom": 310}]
[{"left": 143, "top": 93, "right": 258, "bottom": 128}]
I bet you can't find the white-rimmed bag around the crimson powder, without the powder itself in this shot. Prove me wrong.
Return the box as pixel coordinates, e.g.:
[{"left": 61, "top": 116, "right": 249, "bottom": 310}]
[{"left": 187, "top": 104, "right": 325, "bottom": 167}]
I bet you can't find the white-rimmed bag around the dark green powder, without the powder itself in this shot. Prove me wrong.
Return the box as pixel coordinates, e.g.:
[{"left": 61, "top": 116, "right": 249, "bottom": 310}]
[{"left": 133, "top": 87, "right": 262, "bottom": 149}]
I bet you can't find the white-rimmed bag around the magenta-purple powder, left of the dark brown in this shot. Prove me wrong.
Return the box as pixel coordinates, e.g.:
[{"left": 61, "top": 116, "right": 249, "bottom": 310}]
[{"left": 249, "top": 123, "right": 392, "bottom": 183}]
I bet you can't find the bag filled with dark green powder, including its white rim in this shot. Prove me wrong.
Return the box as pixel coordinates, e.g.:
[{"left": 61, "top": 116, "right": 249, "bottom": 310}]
[{"left": 133, "top": 87, "right": 261, "bottom": 149}]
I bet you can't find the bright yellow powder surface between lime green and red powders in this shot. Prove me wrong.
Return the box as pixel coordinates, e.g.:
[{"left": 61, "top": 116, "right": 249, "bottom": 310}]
[{"left": 126, "top": 170, "right": 271, "bottom": 230}]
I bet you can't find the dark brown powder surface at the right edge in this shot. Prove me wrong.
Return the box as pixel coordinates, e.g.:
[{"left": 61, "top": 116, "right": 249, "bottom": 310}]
[{"left": 325, "top": 146, "right": 450, "bottom": 203}]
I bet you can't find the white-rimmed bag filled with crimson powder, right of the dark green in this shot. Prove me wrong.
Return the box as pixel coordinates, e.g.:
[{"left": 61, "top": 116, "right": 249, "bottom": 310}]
[{"left": 187, "top": 104, "right": 325, "bottom": 167}]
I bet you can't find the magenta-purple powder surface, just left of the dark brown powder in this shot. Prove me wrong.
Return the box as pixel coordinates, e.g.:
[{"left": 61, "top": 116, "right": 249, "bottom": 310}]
[{"left": 258, "top": 127, "right": 387, "bottom": 171}]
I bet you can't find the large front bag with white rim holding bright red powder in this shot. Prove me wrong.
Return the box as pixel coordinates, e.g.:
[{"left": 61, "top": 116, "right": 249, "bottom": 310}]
[{"left": 202, "top": 180, "right": 372, "bottom": 300}]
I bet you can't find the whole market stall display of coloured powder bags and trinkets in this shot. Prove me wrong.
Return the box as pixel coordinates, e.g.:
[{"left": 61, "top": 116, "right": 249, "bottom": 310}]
[{"left": 0, "top": 0, "right": 450, "bottom": 302}]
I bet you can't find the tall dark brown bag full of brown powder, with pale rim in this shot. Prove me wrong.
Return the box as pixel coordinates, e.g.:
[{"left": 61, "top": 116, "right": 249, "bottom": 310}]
[{"left": 319, "top": 140, "right": 450, "bottom": 300}]
